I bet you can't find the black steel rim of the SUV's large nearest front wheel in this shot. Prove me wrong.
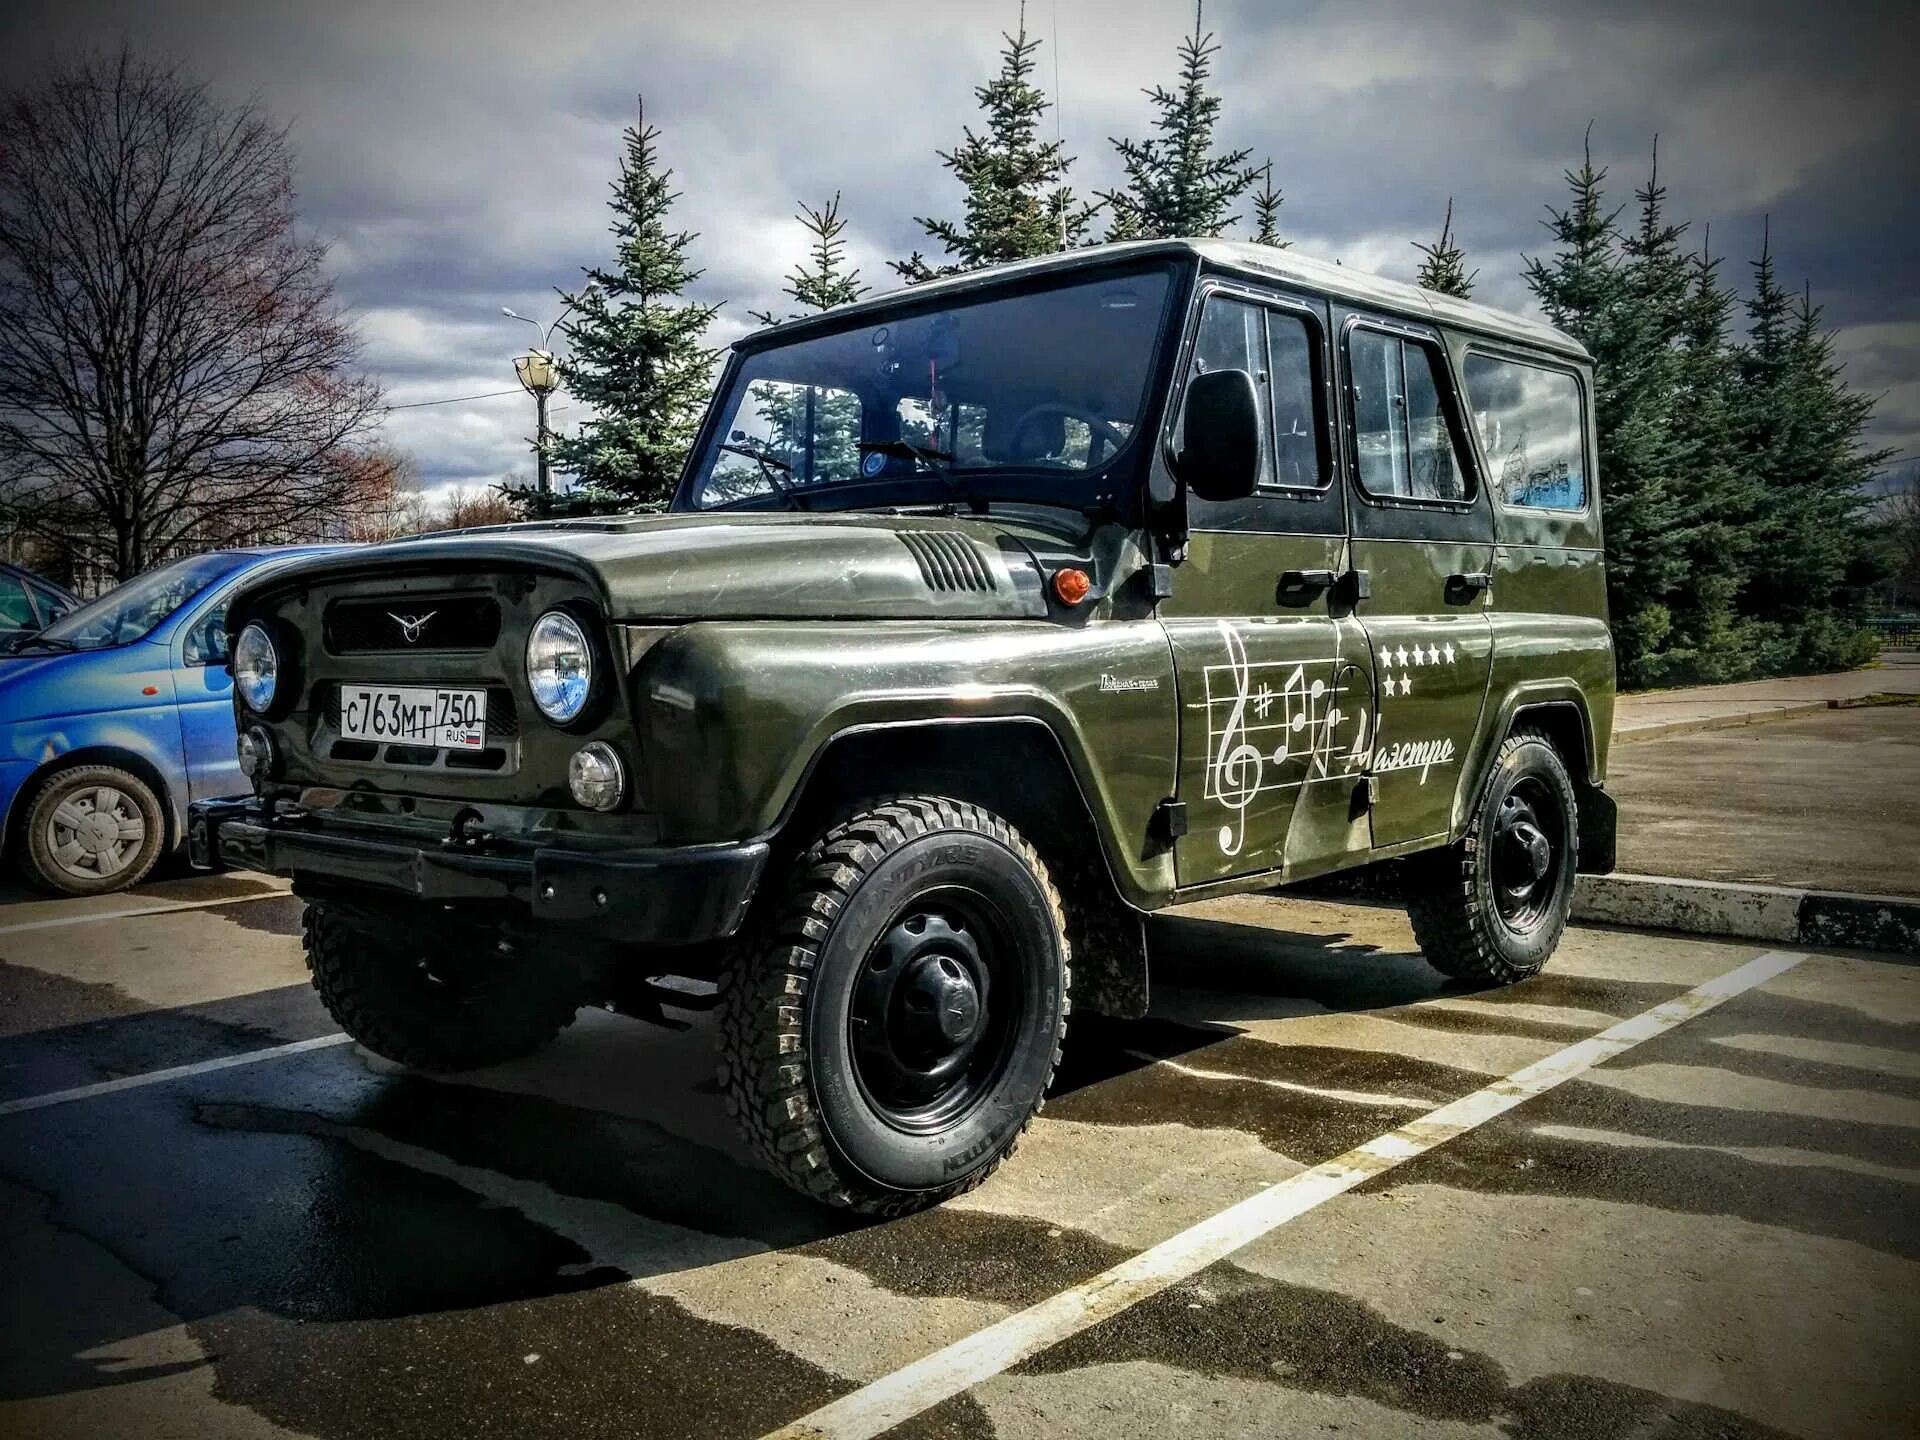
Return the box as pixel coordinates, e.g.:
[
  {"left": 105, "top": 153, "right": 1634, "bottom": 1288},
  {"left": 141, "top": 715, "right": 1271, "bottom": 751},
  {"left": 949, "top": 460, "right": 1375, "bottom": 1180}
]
[{"left": 847, "top": 885, "right": 1027, "bottom": 1135}]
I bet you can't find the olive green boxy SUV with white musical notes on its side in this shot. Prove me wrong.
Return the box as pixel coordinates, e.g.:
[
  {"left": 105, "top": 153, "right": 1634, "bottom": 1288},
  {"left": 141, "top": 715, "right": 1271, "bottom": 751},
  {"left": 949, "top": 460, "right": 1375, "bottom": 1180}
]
[{"left": 192, "top": 240, "right": 1613, "bottom": 1213}]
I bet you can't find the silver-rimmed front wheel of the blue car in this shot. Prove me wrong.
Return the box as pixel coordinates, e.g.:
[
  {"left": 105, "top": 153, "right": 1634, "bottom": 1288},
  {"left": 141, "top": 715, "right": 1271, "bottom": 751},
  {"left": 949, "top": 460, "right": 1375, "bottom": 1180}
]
[{"left": 19, "top": 764, "right": 167, "bottom": 895}]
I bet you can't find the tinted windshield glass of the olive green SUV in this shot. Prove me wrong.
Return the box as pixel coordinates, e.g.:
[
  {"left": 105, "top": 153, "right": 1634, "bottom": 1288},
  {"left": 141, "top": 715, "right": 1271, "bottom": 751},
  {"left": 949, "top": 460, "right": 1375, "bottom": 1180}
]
[{"left": 682, "top": 269, "right": 1171, "bottom": 509}]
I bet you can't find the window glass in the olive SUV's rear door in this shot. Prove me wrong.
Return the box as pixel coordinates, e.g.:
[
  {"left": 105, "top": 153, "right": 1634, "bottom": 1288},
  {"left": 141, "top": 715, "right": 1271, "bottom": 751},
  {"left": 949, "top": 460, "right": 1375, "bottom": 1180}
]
[{"left": 1348, "top": 328, "right": 1473, "bottom": 501}]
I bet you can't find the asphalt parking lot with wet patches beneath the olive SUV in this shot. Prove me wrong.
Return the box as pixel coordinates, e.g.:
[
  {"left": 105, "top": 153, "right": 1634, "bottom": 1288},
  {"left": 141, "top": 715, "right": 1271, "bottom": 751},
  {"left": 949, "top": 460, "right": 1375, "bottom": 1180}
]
[{"left": 0, "top": 876, "right": 1920, "bottom": 1440}]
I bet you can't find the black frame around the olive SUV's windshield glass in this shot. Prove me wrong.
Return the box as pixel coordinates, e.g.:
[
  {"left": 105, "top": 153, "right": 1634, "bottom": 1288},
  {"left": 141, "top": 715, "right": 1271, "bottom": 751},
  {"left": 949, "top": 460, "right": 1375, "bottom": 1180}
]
[{"left": 668, "top": 252, "right": 1196, "bottom": 522}]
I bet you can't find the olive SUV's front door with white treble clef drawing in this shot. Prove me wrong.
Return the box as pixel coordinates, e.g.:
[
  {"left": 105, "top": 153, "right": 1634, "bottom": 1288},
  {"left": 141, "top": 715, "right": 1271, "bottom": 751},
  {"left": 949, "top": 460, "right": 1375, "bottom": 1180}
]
[{"left": 1160, "top": 286, "right": 1367, "bottom": 887}]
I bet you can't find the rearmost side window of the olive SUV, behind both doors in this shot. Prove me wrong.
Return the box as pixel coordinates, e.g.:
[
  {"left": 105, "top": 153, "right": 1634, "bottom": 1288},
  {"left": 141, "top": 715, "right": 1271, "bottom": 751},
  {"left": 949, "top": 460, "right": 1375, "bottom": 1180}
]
[{"left": 1465, "top": 355, "right": 1586, "bottom": 511}]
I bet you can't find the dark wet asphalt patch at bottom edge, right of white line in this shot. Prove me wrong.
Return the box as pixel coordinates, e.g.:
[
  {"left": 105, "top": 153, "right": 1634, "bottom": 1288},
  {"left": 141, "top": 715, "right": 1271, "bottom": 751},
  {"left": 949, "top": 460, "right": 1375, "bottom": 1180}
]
[{"left": 1014, "top": 1263, "right": 1784, "bottom": 1440}]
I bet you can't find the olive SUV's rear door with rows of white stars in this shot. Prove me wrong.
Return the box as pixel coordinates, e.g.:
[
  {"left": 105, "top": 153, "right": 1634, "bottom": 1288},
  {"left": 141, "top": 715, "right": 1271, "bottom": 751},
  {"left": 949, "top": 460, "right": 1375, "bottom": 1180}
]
[{"left": 1342, "top": 315, "right": 1494, "bottom": 849}]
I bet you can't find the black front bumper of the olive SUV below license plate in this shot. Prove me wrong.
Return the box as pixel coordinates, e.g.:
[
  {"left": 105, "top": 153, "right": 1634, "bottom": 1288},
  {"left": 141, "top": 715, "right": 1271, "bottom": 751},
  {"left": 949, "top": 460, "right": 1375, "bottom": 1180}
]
[{"left": 186, "top": 799, "right": 766, "bottom": 945}]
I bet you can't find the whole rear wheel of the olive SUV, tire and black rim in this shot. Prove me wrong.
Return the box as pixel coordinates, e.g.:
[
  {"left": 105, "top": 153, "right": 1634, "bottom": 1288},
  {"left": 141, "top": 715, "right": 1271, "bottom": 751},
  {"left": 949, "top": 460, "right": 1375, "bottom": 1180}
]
[{"left": 1407, "top": 730, "right": 1580, "bottom": 985}]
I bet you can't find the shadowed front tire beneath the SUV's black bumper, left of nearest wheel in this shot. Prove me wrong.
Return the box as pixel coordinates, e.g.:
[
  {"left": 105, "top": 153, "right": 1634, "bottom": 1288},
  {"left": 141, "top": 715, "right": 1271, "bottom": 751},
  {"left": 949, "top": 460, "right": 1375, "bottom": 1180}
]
[{"left": 301, "top": 900, "right": 584, "bottom": 1071}]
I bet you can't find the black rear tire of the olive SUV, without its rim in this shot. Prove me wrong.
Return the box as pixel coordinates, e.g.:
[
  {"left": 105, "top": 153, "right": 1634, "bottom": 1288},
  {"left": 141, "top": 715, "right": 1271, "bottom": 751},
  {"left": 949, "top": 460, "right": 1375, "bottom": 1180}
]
[{"left": 1405, "top": 730, "right": 1580, "bottom": 985}]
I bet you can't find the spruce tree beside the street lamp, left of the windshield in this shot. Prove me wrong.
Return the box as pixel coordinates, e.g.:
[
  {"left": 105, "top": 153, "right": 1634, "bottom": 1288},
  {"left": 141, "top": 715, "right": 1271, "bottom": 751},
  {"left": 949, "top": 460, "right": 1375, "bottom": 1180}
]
[{"left": 549, "top": 101, "right": 720, "bottom": 505}]
